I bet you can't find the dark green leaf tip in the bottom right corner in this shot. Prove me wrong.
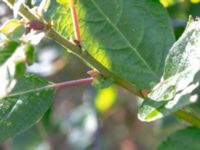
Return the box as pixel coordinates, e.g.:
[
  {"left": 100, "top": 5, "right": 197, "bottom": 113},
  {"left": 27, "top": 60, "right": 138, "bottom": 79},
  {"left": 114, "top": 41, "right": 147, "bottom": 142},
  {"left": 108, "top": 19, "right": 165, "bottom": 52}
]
[{"left": 158, "top": 127, "right": 200, "bottom": 150}]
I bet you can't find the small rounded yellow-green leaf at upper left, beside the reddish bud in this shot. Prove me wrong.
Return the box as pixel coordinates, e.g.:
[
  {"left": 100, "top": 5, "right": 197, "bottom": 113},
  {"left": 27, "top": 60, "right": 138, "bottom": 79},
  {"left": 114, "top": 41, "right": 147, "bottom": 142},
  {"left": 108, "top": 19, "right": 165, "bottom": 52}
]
[{"left": 0, "top": 19, "right": 25, "bottom": 40}]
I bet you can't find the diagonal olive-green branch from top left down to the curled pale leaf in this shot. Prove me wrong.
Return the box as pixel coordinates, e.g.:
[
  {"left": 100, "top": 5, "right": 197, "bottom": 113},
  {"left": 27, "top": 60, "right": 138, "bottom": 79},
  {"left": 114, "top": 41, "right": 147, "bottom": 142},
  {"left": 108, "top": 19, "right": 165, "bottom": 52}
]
[{"left": 3, "top": 0, "right": 143, "bottom": 97}]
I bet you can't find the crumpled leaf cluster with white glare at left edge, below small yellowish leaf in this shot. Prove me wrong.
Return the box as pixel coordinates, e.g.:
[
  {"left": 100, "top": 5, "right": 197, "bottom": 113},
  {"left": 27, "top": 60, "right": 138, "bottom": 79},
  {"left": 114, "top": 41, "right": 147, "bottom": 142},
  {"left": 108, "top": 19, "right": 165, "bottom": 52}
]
[{"left": 0, "top": 40, "right": 34, "bottom": 98}]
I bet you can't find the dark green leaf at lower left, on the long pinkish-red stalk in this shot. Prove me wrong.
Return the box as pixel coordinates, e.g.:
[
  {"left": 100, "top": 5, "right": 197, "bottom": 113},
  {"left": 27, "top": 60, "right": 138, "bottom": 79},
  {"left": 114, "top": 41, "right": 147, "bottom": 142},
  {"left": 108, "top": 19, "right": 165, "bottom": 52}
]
[{"left": 0, "top": 75, "right": 54, "bottom": 140}]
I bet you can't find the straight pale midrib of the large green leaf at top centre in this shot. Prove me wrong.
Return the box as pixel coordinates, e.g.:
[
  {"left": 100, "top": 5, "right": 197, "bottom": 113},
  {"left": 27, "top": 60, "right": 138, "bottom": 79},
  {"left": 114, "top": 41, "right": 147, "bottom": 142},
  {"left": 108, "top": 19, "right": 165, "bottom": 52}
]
[{"left": 91, "top": 0, "right": 159, "bottom": 79}]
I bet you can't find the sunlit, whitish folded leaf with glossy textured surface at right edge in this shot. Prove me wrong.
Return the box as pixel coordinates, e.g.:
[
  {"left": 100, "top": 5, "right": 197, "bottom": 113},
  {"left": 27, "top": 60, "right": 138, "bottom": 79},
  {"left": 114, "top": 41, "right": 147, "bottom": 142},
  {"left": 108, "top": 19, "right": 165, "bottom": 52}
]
[{"left": 138, "top": 17, "right": 200, "bottom": 121}]
